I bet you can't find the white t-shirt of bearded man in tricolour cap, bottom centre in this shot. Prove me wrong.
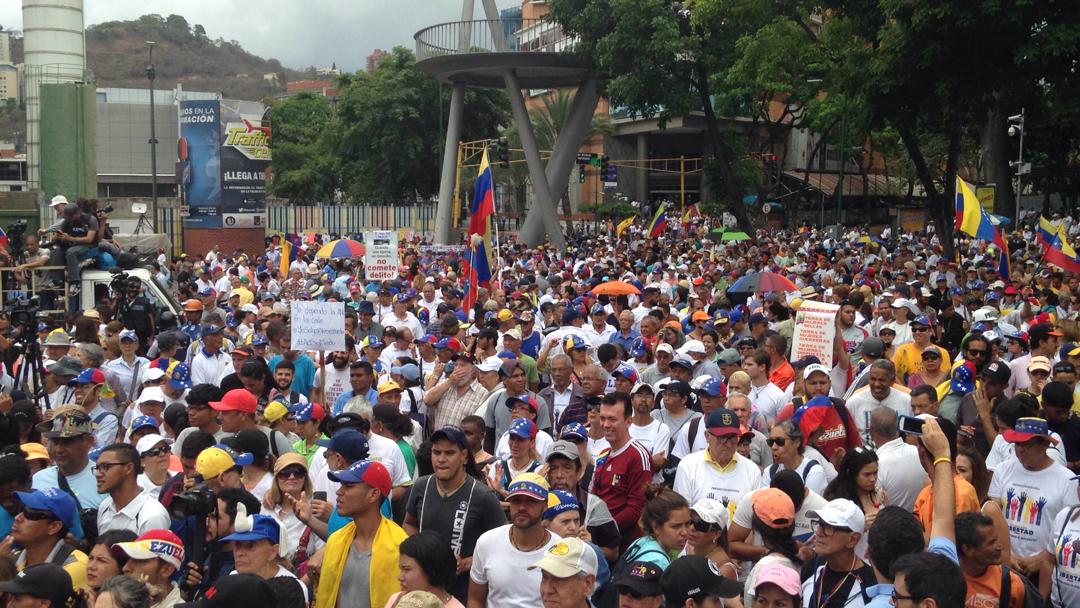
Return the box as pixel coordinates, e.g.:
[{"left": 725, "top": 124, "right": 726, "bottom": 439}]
[{"left": 469, "top": 524, "right": 559, "bottom": 608}]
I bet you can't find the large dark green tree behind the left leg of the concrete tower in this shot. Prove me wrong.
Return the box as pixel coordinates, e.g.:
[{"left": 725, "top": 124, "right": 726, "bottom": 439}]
[{"left": 338, "top": 46, "right": 509, "bottom": 201}]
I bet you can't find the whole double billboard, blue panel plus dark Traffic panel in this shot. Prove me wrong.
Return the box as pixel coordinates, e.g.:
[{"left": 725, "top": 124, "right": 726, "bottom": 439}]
[{"left": 177, "top": 99, "right": 270, "bottom": 228}]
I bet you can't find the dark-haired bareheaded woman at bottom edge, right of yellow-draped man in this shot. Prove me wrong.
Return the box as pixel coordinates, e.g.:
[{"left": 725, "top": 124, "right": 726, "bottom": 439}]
[{"left": 386, "top": 530, "right": 464, "bottom": 608}]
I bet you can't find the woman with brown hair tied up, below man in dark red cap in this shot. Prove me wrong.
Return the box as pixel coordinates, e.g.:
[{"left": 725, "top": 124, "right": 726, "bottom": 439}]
[{"left": 621, "top": 484, "right": 690, "bottom": 569}]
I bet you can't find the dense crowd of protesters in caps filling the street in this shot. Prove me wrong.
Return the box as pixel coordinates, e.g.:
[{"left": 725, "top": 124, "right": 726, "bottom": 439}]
[{"left": 0, "top": 213, "right": 1080, "bottom": 608}]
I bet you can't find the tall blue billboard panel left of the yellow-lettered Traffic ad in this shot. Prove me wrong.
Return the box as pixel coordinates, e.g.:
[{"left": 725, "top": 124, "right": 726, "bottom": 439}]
[{"left": 177, "top": 99, "right": 221, "bottom": 228}]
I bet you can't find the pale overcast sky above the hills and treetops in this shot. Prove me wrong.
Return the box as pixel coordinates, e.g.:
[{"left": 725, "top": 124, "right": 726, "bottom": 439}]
[{"left": 0, "top": 0, "right": 519, "bottom": 71}]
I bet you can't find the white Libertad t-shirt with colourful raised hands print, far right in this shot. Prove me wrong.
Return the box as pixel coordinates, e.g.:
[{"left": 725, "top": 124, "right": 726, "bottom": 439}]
[{"left": 987, "top": 458, "right": 1077, "bottom": 556}]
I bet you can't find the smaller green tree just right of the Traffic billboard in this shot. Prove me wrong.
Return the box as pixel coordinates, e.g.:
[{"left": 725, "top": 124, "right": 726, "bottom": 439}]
[{"left": 269, "top": 91, "right": 340, "bottom": 204}]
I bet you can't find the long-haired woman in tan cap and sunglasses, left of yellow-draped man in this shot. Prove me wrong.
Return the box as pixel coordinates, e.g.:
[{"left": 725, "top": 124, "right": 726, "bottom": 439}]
[{"left": 262, "top": 452, "right": 324, "bottom": 571}]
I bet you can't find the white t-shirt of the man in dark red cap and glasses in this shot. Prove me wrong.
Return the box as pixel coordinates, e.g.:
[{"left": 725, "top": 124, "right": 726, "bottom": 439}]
[{"left": 673, "top": 449, "right": 761, "bottom": 510}]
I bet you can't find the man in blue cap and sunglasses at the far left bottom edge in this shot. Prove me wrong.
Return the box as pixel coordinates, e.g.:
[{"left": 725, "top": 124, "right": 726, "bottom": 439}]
[{"left": 11, "top": 488, "right": 87, "bottom": 590}]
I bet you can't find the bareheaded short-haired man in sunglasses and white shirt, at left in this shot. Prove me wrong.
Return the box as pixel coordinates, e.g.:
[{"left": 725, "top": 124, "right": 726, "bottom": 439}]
[{"left": 93, "top": 435, "right": 172, "bottom": 535}]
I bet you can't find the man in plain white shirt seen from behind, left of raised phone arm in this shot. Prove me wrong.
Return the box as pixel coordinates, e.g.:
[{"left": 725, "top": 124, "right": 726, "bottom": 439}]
[{"left": 869, "top": 407, "right": 927, "bottom": 511}]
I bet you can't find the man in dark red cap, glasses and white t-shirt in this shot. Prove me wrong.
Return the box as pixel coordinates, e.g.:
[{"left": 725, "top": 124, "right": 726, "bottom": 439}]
[{"left": 673, "top": 408, "right": 761, "bottom": 509}]
